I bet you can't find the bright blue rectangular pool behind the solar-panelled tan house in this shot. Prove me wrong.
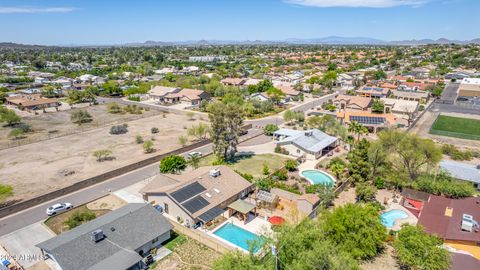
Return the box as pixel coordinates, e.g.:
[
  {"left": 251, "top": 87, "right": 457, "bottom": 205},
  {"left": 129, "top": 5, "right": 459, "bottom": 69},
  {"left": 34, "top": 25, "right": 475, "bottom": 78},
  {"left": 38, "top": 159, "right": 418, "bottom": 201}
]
[{"left": 213, "top": 223, "right": 262, "bottom": 252}]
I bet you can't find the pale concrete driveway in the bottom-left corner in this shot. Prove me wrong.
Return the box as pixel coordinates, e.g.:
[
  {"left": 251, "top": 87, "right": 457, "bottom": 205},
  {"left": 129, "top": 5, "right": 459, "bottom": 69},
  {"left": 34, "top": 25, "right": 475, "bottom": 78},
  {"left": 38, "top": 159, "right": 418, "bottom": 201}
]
[{"left": 0, "top": 222, "right": 55, "bottom": 268}]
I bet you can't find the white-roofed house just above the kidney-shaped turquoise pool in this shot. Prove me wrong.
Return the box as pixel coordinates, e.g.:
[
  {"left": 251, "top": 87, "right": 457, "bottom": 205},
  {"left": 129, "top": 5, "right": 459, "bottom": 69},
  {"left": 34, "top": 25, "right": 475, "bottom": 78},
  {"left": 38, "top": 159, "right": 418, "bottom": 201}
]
[{"left": 273, "top": 129, "right": 337, "bottom": 159}]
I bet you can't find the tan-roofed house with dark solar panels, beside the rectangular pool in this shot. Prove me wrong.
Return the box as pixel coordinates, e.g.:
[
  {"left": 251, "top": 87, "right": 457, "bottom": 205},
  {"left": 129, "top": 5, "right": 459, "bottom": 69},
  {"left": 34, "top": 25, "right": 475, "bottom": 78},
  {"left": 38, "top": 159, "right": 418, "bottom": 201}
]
[{"left": 140, "top": 165, "right": 254, "bottom": 226}]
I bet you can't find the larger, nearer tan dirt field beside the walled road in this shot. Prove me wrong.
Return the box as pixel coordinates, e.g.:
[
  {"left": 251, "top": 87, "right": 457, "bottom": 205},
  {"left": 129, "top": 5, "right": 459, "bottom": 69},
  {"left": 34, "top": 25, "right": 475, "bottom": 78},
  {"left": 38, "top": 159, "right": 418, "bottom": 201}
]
[{"left": 0, "top": 111, "right": 207, "bottom": 199}]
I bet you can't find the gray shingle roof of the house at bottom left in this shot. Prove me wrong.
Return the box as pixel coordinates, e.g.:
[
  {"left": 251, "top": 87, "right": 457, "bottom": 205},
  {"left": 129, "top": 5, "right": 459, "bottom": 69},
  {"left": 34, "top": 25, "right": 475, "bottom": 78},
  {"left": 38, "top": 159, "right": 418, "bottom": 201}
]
[{"left": 37, "top": 203, "right": 173, "bottom": 270}]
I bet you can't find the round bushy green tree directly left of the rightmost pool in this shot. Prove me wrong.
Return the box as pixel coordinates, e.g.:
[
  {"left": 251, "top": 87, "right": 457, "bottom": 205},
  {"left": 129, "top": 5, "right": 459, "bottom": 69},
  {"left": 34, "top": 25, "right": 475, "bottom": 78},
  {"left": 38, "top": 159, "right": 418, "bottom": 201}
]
[{"left": 322, "top": 204, "right": 387, "bottom": 259}]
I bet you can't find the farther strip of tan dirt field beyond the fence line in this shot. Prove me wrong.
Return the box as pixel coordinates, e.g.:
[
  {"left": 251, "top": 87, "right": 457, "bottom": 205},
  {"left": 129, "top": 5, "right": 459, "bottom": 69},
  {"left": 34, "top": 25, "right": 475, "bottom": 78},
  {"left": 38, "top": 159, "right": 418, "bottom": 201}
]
[{"left": 0, "top": 105, "right": 160, "bottom": 149}]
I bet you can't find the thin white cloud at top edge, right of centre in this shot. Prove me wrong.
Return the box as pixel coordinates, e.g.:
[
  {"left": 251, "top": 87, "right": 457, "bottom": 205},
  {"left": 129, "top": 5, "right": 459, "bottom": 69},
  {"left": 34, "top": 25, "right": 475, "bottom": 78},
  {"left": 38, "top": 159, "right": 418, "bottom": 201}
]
[{"left": 284, "top": 0, "right": 430, "bottom": 8}]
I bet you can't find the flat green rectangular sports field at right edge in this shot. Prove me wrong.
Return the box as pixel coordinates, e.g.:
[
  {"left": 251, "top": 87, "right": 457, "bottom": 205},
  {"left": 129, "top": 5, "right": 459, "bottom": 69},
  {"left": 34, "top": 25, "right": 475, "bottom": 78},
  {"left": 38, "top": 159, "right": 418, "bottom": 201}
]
[{"left": 430, "top": 115, "right": 480, "bottom": 140}]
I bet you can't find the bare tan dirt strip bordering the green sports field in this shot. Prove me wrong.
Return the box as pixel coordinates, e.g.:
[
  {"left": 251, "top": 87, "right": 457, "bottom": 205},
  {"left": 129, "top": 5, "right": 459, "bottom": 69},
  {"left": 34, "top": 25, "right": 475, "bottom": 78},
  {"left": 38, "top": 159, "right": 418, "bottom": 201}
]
[{"left": 411, "top": 111, "right": 480, "bottom": 150}]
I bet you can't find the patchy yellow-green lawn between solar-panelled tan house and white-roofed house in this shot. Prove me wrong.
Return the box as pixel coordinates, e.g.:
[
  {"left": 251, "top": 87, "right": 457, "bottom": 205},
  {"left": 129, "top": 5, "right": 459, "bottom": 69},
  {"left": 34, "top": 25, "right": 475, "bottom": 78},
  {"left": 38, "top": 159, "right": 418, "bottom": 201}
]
[{"left": 199, "top": 154, "right": 289, "bottom": 178}]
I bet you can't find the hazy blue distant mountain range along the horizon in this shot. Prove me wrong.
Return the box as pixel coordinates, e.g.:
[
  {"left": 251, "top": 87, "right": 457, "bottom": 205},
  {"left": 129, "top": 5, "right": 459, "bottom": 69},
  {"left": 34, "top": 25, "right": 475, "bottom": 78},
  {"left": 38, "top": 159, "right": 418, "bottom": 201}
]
[{"left": 0, "top": 36, "right": 480, "bottom": 48}]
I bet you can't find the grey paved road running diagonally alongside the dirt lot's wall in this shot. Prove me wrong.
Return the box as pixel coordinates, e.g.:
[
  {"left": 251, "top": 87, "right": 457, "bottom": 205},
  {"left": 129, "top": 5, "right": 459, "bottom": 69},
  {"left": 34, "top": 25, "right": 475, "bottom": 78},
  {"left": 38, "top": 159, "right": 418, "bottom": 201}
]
[{"left": 0, "top": 95, "right": 333, "bottom": 236}]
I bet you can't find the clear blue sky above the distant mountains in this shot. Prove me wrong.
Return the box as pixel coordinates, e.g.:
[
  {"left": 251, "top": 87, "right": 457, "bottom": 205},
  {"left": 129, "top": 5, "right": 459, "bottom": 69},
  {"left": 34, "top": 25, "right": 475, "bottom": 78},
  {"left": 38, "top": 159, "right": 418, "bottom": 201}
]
[{"left": 0, "top": 0, "right": 480, "bottom": 45}]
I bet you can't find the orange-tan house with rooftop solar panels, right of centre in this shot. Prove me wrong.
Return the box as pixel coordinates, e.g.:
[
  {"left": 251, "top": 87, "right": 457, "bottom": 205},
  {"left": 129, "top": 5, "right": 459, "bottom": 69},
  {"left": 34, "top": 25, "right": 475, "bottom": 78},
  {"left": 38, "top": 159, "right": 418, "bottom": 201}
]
[{"left": 337, "top": 111, "right": 396, "bottom": 133}]
